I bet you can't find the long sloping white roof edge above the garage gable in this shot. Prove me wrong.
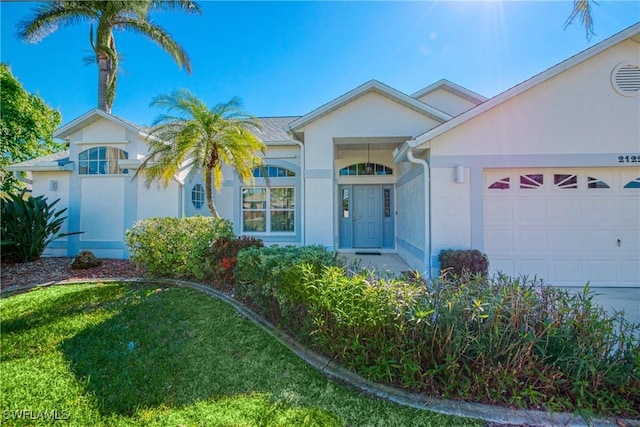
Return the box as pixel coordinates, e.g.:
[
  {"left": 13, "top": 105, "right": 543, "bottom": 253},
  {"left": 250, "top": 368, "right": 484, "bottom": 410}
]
[{"left": 394, "top": 22, "right": 640, "bottom": 162}]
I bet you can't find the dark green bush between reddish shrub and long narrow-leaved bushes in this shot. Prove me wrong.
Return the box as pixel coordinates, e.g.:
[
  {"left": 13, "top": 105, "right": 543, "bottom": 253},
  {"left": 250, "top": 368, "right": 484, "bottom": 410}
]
[{"left": 235, "top": 245, "right": 336, "bottom": 327}]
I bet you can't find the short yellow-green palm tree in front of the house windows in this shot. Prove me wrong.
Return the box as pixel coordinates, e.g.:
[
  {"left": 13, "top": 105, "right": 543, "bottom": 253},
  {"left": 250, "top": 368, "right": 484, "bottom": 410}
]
[{"left": 136, "top": 89, "right": 266, "bottom": 217}]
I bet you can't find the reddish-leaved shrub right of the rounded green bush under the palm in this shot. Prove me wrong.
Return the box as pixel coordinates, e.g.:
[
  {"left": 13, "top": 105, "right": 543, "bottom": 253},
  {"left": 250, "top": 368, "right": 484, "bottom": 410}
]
[{"left": 206, "top": 236, "right": 264, "bottom": 288}]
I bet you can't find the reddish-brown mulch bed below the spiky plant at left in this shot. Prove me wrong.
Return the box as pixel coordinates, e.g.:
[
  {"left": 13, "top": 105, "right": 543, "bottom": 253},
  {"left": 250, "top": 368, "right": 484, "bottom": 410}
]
[{"left": 0, "top": 257, "right": 145, "bottom": 289}]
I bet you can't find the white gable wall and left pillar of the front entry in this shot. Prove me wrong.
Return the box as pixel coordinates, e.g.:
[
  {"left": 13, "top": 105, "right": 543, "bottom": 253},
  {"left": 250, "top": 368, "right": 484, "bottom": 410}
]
[{"left": 304, "top": 93, "right": 437, "bottom": 248}]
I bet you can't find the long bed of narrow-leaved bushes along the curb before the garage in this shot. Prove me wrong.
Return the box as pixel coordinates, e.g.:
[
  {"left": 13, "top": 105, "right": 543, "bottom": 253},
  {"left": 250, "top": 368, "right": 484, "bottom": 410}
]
[{"left": 238, "top": 260, "right": 640, "bottom": 417}]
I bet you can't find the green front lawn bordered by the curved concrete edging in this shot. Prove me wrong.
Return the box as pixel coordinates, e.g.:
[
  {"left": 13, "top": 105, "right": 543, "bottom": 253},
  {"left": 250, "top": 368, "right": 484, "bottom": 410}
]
[{"left": 0, "top": 283, "right": 481, "bottom": 426}]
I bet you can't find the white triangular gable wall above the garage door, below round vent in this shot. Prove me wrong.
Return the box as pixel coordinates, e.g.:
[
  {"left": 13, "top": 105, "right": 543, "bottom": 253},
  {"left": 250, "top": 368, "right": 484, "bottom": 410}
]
[{"left": 431, "top": 40, "right": 640, "bottom": 160}]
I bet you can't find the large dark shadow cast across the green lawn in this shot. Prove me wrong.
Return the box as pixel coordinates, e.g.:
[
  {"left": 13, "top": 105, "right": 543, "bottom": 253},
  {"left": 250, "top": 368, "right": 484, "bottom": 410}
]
[{"left": 60, "top": 287, "right": 340, "bottom": 418}]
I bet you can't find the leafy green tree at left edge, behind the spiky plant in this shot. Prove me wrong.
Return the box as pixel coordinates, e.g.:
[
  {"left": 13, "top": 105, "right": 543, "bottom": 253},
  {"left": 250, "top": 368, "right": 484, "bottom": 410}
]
[{"left": 0, "top": 64, "right": 65, "bottom": 193}]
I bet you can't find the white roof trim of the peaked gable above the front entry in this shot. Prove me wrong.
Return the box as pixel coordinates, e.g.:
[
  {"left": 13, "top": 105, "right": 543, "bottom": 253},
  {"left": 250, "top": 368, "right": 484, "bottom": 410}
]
[{"left": 289, "top": 80, "right": 452, "bottom": 131}]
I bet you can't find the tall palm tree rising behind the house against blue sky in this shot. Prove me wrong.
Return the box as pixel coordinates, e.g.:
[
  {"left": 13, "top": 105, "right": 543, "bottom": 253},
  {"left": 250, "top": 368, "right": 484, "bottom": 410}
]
[{"left": 18, "top": 0, "right": 200, "bottom": 113}]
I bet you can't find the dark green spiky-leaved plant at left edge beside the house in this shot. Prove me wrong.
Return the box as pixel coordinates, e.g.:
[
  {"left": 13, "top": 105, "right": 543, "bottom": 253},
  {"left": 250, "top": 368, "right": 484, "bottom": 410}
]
[{"left": 0, "top": 191, "right": 69, "bottom": 262}]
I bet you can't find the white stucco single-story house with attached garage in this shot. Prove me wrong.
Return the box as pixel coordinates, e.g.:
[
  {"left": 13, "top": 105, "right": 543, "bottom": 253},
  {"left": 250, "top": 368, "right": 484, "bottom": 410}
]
[{"left": 10, "top": 24, "right": 640, "bottom": 287}]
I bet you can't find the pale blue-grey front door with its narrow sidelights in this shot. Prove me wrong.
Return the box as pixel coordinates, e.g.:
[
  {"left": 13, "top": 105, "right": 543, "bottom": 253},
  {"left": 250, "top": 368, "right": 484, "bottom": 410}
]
[{"left": 339, "top": 184, "right": 394, "bottom": 249}]
